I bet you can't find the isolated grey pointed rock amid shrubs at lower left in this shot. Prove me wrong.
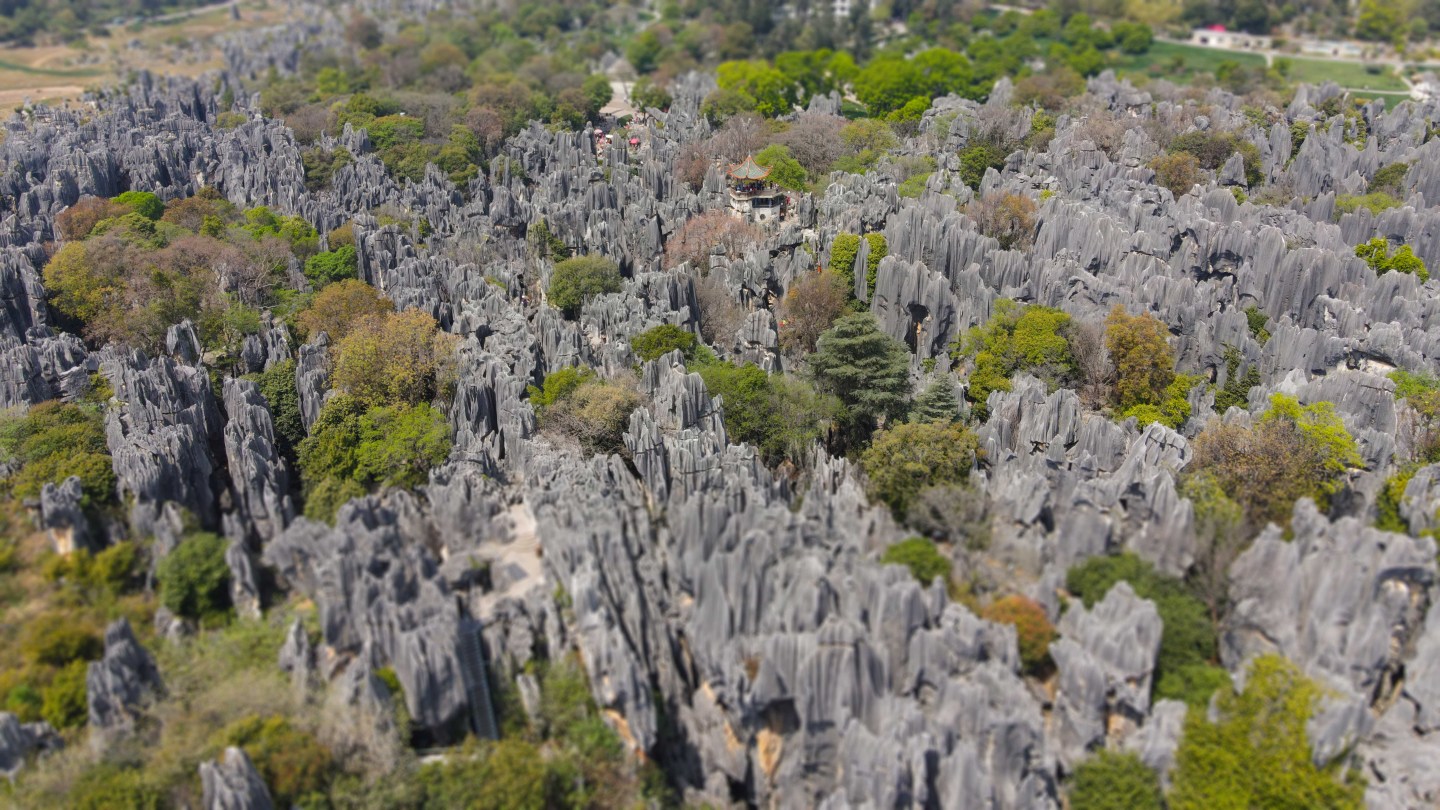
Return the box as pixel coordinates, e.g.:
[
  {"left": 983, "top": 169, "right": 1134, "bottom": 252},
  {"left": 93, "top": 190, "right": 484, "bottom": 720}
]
[{"left": 85, "top": 618, "right": 164, "bottom": 748}]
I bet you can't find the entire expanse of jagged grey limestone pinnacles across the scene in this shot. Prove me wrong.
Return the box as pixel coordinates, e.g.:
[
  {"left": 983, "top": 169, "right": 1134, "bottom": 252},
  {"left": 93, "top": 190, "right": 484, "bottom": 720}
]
[{"left": 0, "top": 42, "right": 1440, "bottom": 809}]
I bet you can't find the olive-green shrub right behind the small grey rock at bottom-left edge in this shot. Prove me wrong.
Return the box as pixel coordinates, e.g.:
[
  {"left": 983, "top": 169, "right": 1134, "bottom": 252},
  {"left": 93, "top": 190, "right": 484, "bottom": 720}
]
[{"left": 220, "top": 715, "right": 331, "bottom": 807}]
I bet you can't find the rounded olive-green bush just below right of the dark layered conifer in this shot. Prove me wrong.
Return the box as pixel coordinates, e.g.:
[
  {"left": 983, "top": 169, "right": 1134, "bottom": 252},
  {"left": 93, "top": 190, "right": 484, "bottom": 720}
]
[{"left": 860, "top": 422, "right": 979, "bottom": 519}]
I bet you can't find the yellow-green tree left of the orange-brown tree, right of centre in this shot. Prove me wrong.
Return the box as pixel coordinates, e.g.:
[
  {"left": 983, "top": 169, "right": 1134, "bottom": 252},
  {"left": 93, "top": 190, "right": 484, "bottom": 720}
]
[{"left": 950, "top": 298, "right": 1074, "bottom": 419}]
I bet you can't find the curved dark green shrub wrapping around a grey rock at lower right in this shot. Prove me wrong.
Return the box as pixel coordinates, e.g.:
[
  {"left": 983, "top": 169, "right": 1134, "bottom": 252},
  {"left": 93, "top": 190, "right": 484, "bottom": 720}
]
[{"left": 1066, "top": 553, "right": 1224, "bottom": 705}]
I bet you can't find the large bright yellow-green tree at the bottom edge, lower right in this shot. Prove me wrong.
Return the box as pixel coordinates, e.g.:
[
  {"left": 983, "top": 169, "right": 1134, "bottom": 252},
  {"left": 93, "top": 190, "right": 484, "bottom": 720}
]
[{"left": 1169, "top": 656, "right": 1364, "bottom": 810}]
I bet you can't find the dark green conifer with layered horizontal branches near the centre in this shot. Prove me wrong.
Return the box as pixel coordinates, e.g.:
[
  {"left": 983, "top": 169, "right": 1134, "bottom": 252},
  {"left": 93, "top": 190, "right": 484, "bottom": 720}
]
[{"left": 809, "top": 313, "right": 910, "bottom": 440}]
